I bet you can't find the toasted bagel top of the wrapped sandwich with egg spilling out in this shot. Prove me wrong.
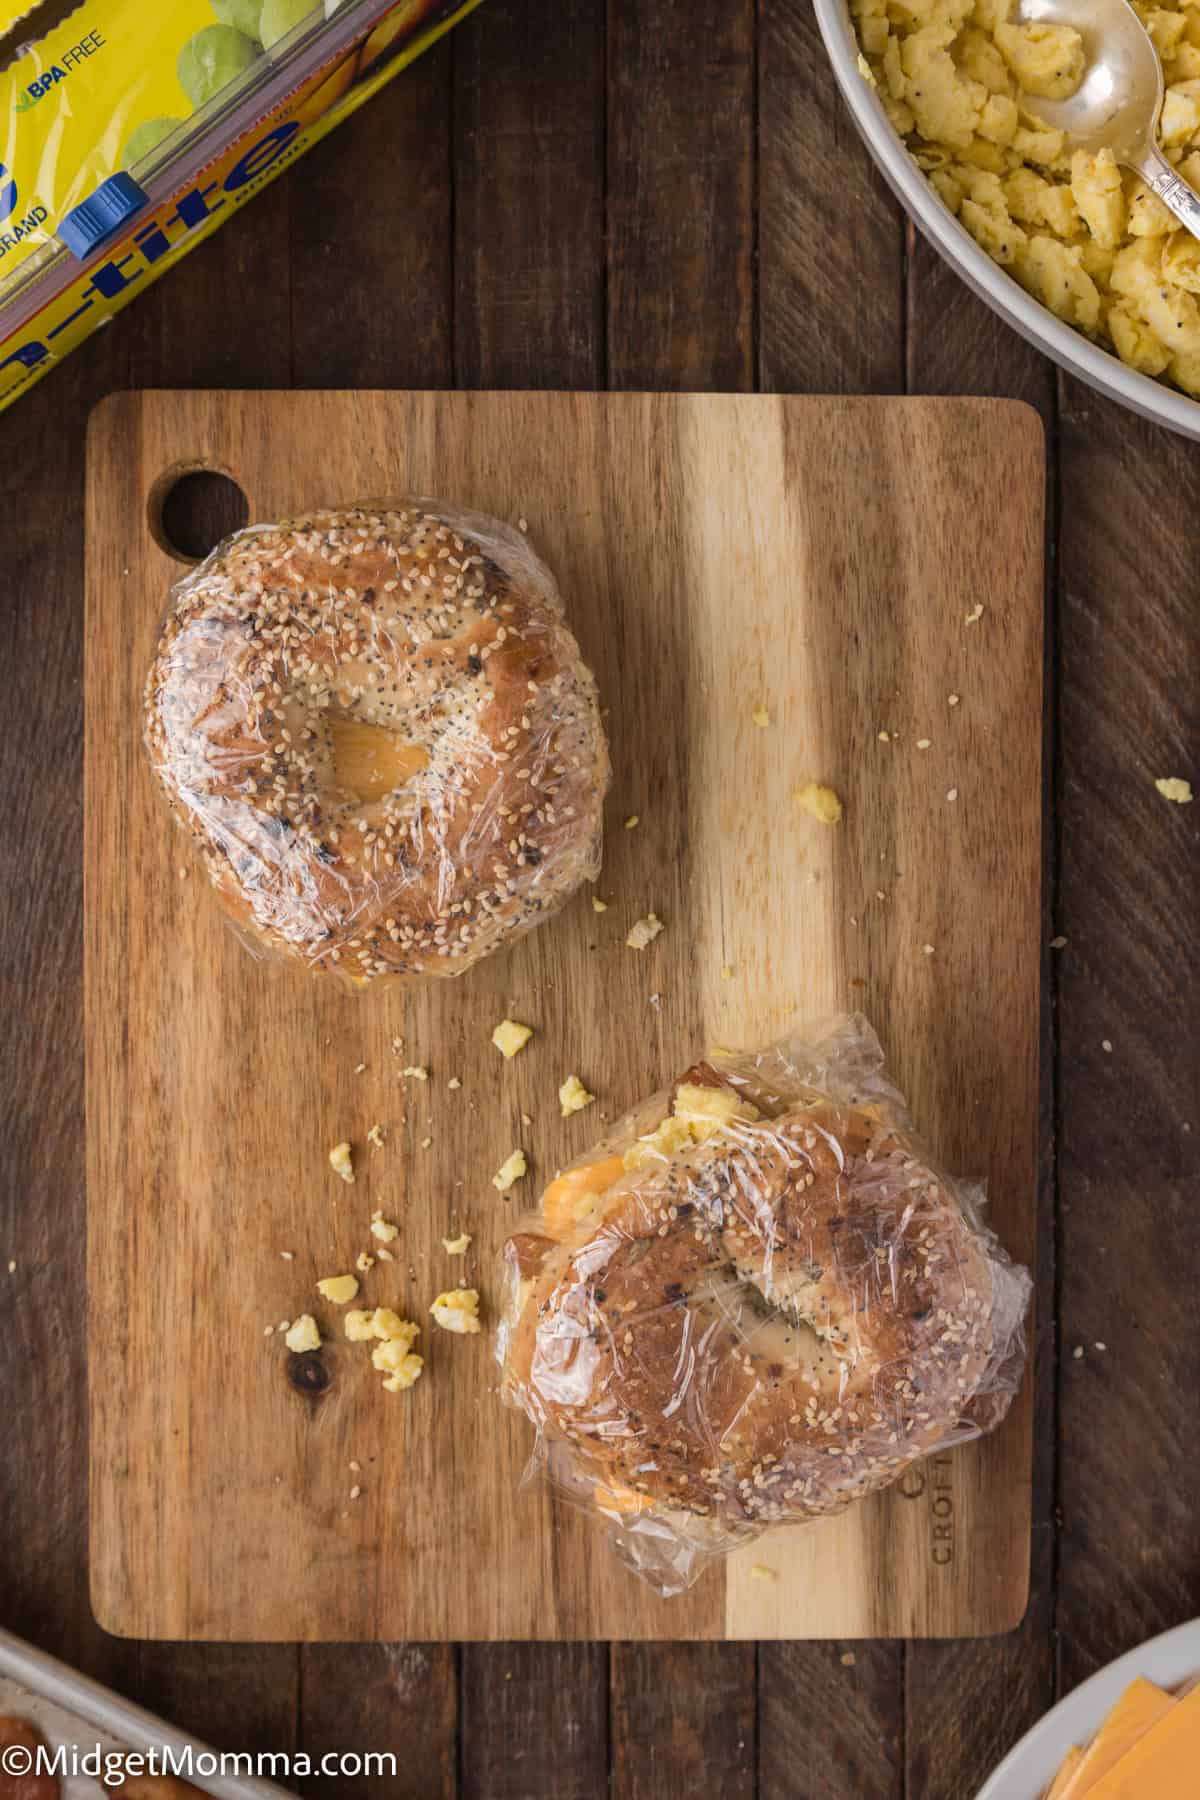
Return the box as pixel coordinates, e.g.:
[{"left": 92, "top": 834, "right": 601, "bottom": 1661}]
[{"left": 506, "top": 1067, "right": 1011, "bottom": 1532}]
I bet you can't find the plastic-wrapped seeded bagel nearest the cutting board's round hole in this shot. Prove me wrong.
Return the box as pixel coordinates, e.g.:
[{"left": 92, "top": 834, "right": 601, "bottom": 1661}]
[{"left": 146, "top": 500, "right": 610, "bottom": 986}]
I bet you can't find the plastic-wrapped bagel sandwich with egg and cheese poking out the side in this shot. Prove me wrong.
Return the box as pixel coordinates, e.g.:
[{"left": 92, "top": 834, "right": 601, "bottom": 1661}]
[{"left": 498, "top": 1015, "right": 1033, "bottom": 1595}]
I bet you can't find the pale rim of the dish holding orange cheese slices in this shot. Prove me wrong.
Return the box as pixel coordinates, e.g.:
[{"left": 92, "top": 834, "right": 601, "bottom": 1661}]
[{"left": 977, "top": 1618, "right": 1200, "bottom": 1800}]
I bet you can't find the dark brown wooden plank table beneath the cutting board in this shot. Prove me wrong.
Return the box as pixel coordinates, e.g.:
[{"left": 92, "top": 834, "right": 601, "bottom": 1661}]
[{"left": 0, "top": 0, "right": 1200, "bottom": 1800}]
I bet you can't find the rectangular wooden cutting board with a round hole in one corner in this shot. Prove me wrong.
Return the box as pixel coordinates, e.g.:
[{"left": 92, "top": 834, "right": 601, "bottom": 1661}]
[{"left": 85, "top": 392, "right": 1043, "bottom": 1640}]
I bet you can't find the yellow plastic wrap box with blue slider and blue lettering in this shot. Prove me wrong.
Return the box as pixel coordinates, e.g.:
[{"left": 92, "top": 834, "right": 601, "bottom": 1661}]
[{"left": 0, "top": 0, "right": 480, "bottom": 410}]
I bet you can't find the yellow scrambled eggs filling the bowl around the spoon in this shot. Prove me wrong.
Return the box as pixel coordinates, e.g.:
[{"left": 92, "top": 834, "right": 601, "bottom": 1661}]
[{"left": 851, "top": 0, "right": 1200, "bottom": 396}]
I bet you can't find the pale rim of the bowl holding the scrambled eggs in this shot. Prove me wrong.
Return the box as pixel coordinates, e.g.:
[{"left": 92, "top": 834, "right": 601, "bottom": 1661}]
[{"left": 813, "top": 0, "right": 1200, "bottom": 439}]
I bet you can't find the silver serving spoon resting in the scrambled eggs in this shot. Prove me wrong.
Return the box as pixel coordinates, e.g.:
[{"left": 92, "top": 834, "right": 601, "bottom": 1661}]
[{"left": 1018, "top": 0, "right": 1200, "bottom": 238}]
